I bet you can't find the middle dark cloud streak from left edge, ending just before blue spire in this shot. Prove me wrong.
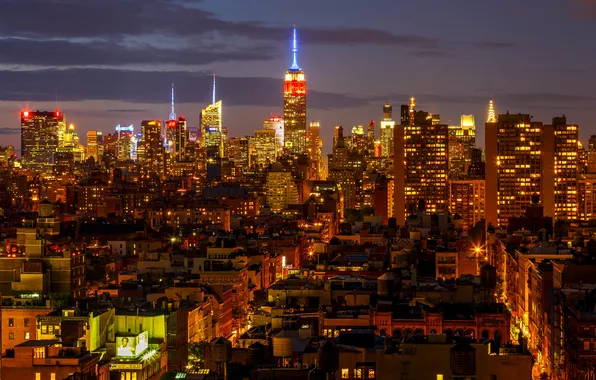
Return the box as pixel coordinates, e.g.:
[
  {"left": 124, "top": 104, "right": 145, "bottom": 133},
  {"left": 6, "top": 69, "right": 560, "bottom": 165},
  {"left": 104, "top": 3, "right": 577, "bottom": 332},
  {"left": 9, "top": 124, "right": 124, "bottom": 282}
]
[{"left": 0, "top": 38, "right": 276, "bottom": 66}]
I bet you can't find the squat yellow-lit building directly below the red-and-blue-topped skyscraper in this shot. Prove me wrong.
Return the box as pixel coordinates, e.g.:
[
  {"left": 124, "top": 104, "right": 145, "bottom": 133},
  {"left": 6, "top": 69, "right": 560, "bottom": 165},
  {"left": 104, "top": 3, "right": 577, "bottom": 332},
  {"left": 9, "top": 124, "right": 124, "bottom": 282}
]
[{"left": 266, "top": 162, "right": 298, "bottom": 213}]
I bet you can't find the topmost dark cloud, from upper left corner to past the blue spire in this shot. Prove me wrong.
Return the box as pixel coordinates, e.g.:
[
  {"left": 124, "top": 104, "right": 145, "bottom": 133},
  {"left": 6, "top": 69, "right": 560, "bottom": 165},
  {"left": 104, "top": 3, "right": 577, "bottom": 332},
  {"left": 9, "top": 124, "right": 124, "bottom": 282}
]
[{"left": 0, "top": 0, "right": 438, "bottom": 47}]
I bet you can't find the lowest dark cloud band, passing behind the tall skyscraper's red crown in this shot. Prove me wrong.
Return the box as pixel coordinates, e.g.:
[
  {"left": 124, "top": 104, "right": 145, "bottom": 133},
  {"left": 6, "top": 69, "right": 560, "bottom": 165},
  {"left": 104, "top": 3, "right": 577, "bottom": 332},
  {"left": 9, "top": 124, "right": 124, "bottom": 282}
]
[{"left": 0, "top": 68, "right": 369, "bottom": 109}]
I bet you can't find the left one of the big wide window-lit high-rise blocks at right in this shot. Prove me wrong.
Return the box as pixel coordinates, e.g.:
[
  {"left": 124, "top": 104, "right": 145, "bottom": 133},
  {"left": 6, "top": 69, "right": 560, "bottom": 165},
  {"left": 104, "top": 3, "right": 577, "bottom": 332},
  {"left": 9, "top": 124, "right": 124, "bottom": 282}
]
[{"left": 393, "top": 98, "right": 449, "bottom": 218}]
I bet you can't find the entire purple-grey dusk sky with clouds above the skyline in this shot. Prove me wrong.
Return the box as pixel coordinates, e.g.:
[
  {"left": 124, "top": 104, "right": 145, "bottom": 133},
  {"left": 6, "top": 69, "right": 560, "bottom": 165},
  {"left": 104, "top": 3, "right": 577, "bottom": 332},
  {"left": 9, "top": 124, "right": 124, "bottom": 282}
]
[{"left": 0, "top": 0, "right": 596, "bottom": 151}]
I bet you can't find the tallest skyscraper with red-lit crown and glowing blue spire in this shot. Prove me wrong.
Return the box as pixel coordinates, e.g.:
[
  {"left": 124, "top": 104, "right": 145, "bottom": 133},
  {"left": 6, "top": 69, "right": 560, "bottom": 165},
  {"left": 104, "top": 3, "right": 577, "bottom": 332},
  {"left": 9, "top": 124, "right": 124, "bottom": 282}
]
[{"left": 284, "top": 28, "right": 307, "bottom": 156}]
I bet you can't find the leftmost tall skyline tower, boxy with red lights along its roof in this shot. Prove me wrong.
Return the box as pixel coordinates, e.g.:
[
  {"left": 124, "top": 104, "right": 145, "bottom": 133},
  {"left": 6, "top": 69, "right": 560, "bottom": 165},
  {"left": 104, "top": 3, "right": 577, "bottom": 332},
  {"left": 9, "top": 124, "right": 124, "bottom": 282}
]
[{"left": 21, "top": 111, "right": 66, "bottom": 173}]
